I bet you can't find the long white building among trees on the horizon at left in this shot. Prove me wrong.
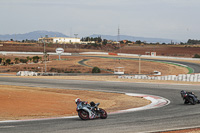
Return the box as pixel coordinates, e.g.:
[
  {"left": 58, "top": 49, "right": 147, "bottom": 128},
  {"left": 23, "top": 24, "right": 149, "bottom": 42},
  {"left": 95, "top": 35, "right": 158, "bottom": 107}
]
[{"left": 38, "top": 37, "right": 81, "bottom": 44}]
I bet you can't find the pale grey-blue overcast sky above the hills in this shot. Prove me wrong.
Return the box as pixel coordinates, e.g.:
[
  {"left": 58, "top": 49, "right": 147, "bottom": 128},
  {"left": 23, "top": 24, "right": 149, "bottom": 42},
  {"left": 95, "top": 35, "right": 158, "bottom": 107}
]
[{"left": 0, "top": 0, "right": 200, "bottom": 41}]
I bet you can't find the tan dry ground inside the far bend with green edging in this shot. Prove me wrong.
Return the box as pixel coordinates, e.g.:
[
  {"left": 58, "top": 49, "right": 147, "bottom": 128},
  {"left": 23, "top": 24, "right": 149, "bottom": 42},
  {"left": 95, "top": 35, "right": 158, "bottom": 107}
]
[{"left": 87, "top": 58, "right": 188, "bottom": 75}]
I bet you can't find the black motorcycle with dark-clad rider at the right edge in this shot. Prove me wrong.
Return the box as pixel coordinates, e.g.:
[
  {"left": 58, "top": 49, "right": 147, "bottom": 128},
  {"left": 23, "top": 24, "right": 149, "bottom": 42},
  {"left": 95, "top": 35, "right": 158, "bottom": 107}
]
[{"left": 181, "top": 90, "right": 199, "bottom": 105}]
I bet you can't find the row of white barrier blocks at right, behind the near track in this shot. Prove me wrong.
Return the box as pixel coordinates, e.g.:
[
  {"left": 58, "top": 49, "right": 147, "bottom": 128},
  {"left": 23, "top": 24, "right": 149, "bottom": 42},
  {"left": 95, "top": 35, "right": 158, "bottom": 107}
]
[{"left": 118, "top": 73, "right": 200, "bottom": 82}]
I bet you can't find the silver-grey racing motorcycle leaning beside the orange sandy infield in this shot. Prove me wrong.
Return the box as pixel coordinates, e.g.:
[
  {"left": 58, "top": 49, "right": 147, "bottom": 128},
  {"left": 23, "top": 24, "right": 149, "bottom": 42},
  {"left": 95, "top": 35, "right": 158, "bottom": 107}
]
[{"left": 76, "top": 101, "right": 107, "bottom": 120}]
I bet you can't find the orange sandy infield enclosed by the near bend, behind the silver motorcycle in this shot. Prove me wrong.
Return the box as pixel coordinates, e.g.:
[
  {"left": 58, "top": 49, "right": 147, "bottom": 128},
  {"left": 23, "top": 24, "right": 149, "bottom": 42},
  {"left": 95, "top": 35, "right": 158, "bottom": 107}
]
[{"left": 0, "top": 85, "right": 150, "bottom": 120}]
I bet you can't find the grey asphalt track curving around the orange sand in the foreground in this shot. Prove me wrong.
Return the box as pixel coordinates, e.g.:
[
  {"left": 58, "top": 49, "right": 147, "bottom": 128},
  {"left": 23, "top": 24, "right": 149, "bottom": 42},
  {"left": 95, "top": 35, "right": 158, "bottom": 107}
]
[{"left": 0, "top": 59, "right": 200, "bottom": 133}]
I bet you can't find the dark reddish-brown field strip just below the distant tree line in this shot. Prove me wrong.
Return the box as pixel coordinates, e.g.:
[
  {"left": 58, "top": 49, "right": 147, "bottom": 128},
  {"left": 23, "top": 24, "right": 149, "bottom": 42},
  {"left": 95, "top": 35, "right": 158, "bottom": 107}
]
[{"left": 0, "top": 42, "right": 200, "bottom": 57}]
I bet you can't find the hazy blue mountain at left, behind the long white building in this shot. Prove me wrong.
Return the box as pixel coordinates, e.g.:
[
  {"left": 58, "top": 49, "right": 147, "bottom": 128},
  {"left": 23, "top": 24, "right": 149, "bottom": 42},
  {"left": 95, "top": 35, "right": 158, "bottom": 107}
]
[{"left": 0, "top": 31, "right": 67, "bottom": 41}]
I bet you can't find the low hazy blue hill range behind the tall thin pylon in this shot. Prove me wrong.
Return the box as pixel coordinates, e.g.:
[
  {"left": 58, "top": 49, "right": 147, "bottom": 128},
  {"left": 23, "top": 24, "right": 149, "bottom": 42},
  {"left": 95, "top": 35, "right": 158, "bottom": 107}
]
[{"left": 90, "top": 34, "right": 177, "bottom": 43}]
